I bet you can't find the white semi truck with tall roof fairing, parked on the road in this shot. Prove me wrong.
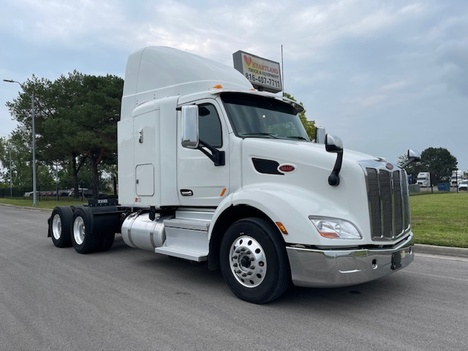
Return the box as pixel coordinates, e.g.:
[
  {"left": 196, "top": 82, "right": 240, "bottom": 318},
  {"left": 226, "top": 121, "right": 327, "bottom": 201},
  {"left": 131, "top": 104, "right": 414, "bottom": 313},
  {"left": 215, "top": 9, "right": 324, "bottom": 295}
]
[{"left": 48, "top": 47, "right": 413, "bottom": 304}]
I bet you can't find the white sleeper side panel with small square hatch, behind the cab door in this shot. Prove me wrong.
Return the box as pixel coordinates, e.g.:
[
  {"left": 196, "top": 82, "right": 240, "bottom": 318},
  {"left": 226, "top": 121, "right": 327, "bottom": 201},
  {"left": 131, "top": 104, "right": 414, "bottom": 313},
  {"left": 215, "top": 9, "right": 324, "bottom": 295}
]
[{"left": 118, "top": 97, "right": 178, "bottom": 206}]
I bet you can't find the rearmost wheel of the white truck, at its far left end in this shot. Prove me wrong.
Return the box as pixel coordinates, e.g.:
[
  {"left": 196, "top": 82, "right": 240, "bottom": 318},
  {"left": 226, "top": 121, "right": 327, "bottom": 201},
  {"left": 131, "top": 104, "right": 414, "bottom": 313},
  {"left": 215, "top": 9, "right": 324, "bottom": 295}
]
[{"left": 49, "top": 206, "right": 73, "bottom": 247}]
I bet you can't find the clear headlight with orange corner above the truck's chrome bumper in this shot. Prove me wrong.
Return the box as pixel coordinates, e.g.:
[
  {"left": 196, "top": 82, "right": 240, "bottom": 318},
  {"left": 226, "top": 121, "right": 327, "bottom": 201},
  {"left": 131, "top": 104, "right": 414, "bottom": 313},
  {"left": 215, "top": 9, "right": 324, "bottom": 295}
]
[{"left": 309, "top": 216, "right": 362, "bottom": 239}]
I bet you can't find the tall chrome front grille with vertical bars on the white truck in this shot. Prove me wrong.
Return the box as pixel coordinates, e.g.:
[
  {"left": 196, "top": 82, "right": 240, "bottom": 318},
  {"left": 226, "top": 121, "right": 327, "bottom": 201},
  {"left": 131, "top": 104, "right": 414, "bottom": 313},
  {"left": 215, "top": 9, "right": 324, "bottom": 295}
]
[{"left": 365, "top": 167, "right": 410, "bottom": 240}]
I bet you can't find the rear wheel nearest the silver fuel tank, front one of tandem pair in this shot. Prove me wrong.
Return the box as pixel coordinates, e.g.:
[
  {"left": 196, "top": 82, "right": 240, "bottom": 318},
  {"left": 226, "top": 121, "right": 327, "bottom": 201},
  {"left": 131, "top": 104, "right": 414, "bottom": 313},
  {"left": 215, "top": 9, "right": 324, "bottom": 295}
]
[{"left": 71, "top": 207, "right": 99, "bottom": 254}]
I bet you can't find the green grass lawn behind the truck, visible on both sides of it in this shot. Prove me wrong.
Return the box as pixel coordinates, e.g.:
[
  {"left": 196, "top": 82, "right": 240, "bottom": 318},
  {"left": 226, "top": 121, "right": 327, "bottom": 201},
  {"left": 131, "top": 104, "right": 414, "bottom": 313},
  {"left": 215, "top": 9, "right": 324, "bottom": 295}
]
[{"left": 0, "top": 192, "right": 468, "bottom": 248}]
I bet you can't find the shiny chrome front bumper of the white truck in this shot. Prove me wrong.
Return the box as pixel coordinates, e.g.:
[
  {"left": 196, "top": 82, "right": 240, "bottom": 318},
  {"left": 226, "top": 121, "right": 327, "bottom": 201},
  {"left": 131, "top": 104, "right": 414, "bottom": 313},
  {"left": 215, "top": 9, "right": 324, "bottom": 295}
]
[{"left": 287, "top": 233, "right": 414, "bottom": 288}]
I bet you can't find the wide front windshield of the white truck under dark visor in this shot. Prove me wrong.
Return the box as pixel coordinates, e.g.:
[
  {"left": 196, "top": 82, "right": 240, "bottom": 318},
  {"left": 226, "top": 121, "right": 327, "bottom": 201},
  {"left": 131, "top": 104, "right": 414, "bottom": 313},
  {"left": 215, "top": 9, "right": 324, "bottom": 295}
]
[{"left": 221, "top": 93, "right": 309, "bottom": 141}]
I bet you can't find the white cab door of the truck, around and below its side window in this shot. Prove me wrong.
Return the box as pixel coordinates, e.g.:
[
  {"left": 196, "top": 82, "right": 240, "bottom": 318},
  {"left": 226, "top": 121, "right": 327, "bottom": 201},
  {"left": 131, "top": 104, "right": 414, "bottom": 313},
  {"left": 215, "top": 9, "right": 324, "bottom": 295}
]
[{"left": 177, "top": 100, "right": 229, "bottom": 206}]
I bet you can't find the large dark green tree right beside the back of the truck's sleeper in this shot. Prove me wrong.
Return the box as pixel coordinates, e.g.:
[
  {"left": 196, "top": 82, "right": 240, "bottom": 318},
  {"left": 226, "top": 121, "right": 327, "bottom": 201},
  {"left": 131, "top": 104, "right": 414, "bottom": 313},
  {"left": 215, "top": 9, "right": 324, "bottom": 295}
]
[{"left": 45, "top": 71, "right": 123, "bottom": 197}]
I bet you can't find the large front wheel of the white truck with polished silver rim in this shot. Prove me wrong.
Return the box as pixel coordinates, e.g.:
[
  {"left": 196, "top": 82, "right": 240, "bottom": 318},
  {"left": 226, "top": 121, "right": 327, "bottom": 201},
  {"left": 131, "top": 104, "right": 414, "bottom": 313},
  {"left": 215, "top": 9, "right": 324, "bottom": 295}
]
[{"left": 220, "top": 218, "right": 291, "bottom": 304}]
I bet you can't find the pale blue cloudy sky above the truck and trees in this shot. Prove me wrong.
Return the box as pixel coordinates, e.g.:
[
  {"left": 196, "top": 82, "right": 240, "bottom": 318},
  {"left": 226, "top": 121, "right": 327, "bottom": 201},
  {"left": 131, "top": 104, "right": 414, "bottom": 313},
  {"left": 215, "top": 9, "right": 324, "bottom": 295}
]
[{"left": 0, "top": 0, "right": 468, "bottom": 171}]
